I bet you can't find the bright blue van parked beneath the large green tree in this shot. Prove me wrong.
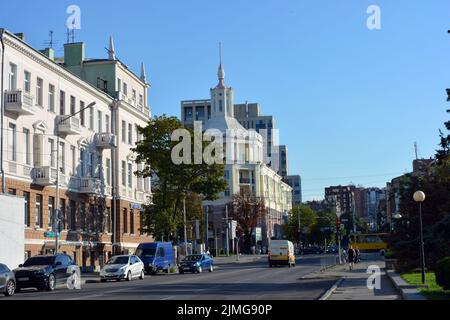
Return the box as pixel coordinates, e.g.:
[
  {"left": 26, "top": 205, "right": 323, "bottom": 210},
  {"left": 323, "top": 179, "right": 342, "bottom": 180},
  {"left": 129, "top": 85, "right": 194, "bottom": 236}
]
[{"left": 136, "top": 242, "right": 174, "bottom": 274}]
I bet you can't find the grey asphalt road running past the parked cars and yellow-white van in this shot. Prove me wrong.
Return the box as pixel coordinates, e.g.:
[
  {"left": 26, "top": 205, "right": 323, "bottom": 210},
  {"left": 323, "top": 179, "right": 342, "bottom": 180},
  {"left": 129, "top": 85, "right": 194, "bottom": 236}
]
[{"left": 5, "top": 256, "right": 335, "bottom": 300}]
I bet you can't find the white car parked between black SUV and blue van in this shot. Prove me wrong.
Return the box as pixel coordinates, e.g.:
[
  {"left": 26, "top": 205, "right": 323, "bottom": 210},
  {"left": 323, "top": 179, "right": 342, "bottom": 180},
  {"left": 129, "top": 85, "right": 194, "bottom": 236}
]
[{"left": 100, "top": 255, "right": 145, "bottom": 282}]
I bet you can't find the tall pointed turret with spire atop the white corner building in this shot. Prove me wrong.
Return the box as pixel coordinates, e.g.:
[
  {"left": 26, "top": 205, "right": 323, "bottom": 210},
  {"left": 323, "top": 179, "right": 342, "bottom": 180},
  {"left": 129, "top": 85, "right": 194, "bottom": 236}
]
[{"left": 211, "top": 43, "right": 234, "bottom": 118}]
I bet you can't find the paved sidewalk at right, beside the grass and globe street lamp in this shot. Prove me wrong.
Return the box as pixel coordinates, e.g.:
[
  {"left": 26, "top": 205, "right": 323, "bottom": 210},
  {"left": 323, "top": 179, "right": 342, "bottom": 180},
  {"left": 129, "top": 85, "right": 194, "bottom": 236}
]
[{"left": 304, "top": 260, "right": 401, "bottom": 300}]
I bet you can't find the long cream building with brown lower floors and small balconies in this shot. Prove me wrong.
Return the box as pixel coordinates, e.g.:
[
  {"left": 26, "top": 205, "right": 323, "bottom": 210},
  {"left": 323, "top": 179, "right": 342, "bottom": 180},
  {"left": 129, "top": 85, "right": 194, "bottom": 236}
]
[{"left": 0, "top": 29, "right": 151, "bottom": 267}]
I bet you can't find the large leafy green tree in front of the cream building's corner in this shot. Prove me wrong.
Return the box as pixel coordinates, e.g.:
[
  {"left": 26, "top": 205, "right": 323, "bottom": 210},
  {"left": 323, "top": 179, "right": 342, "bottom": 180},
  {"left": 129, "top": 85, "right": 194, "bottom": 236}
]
[{"left": 133, "top": 115, "right": 226, "bottom": 239}]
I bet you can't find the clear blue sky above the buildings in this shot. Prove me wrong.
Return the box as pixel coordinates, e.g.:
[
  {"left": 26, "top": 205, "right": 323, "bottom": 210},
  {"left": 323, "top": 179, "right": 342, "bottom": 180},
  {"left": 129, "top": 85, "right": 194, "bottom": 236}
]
[{"left": 0, "top": 0, "right": 450, "bottom": 200}]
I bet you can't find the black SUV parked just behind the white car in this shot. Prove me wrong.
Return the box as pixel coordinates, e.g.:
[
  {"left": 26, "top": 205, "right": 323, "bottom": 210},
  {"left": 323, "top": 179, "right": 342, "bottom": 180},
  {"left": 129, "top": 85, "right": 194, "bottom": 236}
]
[{"left": 14, "top": 254, "right": 79, "bottom": 291}]
